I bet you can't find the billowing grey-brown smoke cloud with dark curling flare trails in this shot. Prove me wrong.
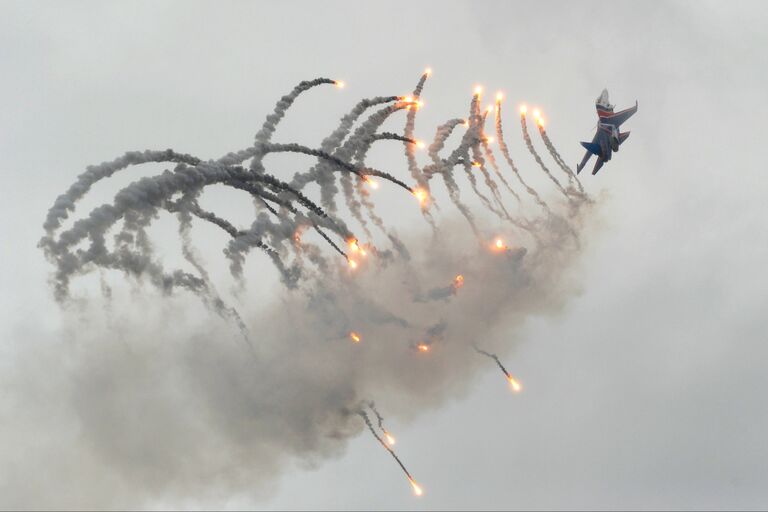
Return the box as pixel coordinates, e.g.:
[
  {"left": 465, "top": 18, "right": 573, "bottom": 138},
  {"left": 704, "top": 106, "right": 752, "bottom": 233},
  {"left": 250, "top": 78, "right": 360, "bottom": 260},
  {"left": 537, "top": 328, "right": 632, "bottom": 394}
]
[{"left": 7, "top": 72, "right": 596, "bottom": 508}]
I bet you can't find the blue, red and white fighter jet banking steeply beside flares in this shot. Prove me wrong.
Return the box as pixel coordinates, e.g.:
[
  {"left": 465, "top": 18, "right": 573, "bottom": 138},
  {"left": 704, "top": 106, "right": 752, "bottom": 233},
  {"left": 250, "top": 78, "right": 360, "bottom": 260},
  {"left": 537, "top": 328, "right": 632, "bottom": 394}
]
[{"left": 576, "top": 89, "right": 637, "bottom": 174}]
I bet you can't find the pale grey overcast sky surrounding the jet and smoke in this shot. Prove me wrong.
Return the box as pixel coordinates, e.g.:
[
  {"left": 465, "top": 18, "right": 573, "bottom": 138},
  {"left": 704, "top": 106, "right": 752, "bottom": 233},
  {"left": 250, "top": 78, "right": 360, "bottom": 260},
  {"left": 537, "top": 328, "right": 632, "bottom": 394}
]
[{"left": 0, "top": 1, "right": 768, "bottom": 509}]
